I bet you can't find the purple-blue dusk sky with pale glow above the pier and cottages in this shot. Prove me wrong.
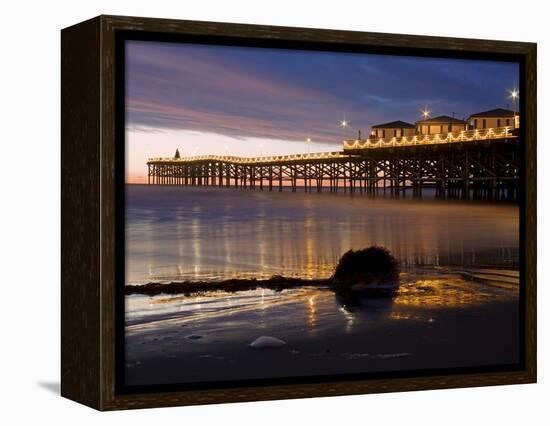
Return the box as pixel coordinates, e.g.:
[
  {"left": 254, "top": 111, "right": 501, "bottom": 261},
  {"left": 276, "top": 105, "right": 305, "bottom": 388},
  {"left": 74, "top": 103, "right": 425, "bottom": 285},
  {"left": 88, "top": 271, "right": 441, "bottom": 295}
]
[{"left": 126, "top": 41, "right": 519, "bottom": 183}]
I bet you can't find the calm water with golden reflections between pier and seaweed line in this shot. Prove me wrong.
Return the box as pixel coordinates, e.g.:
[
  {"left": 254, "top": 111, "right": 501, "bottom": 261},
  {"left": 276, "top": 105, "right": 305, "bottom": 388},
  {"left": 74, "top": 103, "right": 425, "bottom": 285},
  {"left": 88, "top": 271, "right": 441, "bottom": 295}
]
[{"left": 126, "top": 185, "right": 519, "bottom": 284}]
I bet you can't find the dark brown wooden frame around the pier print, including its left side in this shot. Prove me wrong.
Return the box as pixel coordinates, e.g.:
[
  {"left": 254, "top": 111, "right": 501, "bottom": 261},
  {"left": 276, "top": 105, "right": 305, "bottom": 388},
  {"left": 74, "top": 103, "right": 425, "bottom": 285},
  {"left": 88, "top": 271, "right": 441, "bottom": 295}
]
[{"left": 61, "top": 16, "right": 537, "bottom": 410}]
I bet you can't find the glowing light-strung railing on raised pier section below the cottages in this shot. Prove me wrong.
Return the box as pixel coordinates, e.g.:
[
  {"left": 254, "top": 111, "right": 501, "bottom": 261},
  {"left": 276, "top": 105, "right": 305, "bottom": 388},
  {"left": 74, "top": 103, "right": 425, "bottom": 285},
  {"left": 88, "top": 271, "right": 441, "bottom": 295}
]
[{"left": 344, "top": 126, "right": 516, "bottom": 151}]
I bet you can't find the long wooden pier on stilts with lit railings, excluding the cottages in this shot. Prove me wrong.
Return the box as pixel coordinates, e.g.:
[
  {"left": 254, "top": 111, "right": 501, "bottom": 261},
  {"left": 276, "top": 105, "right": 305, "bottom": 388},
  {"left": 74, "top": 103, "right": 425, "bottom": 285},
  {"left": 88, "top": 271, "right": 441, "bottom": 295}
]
[{"left": 147, "top": 127, "right": 520, "bottom": 201}]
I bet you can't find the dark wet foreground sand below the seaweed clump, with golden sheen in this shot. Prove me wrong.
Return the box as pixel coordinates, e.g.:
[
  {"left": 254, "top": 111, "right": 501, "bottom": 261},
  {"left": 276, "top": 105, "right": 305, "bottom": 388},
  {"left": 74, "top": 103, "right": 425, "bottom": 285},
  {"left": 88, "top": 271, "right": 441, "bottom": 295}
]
[{"left": 126, "top": 270, "right": 519, "bottom": 386}]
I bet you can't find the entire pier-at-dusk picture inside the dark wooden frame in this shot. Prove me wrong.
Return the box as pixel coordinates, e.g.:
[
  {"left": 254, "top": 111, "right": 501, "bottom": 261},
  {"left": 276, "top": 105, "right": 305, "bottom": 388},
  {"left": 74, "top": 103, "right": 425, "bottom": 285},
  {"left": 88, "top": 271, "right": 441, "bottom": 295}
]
[{"left": 121, "top": 40, "right": 523, "bottom": 389}]
